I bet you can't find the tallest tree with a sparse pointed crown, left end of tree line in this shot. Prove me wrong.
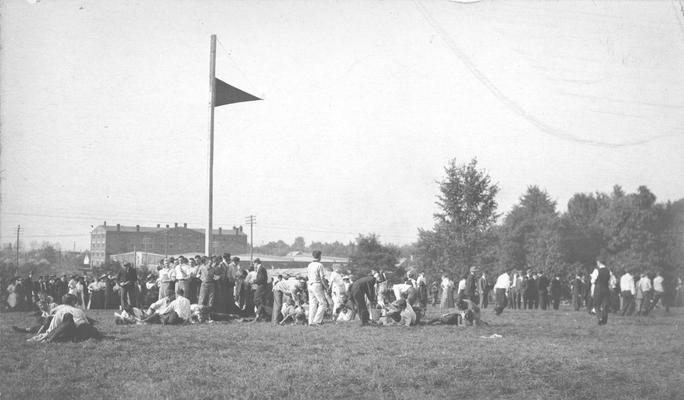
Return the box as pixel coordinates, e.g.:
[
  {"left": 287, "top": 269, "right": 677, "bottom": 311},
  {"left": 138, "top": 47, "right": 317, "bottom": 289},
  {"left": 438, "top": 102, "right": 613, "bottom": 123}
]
[{"left": 417, "top": 159, "right": 499, "bottom": 275}]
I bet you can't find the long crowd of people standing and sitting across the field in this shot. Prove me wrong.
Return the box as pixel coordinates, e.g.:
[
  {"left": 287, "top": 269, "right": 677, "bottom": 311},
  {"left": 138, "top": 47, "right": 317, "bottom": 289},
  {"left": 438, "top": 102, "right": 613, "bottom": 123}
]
[{"left": 7, "top": 251, "right": 681, "bottom": 341}]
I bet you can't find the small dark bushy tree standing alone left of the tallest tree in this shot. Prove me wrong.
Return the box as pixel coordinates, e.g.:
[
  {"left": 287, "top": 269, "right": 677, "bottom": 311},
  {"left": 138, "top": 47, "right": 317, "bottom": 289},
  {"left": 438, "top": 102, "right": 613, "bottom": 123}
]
[{"left": 350, "top": 233, "right": 399, "bottom": 277}]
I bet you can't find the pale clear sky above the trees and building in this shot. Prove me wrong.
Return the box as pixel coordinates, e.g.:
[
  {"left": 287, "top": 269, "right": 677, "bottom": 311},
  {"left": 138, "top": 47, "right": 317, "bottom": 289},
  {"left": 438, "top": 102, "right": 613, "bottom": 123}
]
[{"left": 0, "top": 0, "right": 684, "bottom": 250}]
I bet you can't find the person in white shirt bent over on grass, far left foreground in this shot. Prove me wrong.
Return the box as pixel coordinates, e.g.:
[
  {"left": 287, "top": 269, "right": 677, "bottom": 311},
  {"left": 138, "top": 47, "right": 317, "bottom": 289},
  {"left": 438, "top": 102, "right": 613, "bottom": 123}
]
[{"left": 28, "top": 294, "right": 104, "bottom": 343}]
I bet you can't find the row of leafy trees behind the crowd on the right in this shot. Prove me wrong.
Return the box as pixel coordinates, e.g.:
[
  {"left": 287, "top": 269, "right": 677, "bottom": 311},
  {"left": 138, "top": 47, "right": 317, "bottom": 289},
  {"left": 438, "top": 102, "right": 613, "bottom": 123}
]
[{"left": 416, "top": 159, "right": 684, "bottom": 277}]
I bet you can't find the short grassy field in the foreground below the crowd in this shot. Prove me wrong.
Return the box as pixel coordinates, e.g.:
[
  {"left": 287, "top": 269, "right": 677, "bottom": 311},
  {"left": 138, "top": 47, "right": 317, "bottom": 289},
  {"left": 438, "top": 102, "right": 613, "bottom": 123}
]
[{"left": 0, "top": 308, "right": 684, "bottom": 400}]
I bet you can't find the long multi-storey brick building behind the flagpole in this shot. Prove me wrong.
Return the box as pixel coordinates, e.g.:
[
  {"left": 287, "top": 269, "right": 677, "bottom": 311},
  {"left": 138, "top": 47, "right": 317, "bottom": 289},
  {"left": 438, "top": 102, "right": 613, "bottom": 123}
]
[{"left": 90, "top": 221, "right": 249, "bottom": 266}]
